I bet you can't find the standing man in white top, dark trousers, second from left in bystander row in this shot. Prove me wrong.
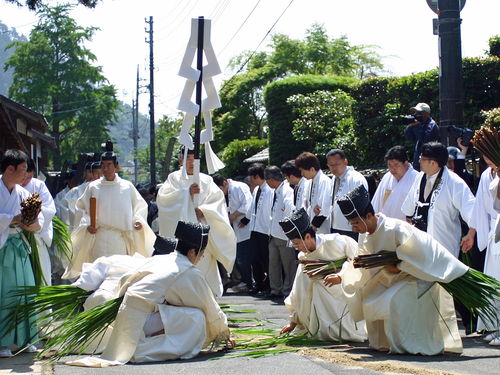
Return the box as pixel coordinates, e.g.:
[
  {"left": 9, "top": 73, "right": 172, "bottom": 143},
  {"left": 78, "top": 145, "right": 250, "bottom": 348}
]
[{"left": 238, "top": 163, "right": 273, "bottom": 295}]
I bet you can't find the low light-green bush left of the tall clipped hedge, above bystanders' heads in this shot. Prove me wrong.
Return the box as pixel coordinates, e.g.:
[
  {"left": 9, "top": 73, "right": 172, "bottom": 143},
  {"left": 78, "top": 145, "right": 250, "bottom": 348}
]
[{"left": 219, "top": 138, "right": 268, "bottom": 177}]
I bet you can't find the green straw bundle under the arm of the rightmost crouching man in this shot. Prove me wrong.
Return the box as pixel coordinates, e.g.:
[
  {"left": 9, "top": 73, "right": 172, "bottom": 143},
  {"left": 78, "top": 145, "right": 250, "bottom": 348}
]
[{"left": 354, "top": 251, "right": 500, "bottom": 329}]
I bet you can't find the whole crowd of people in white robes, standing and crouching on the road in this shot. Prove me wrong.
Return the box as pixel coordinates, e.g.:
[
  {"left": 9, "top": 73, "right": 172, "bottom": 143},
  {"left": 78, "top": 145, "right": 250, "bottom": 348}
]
[{"left": 0, "top": 103, "right": 500, "bottom": 366}]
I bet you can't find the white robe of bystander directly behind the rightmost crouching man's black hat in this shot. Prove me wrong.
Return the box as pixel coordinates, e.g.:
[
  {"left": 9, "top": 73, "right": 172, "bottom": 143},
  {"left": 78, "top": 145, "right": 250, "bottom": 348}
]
[{"left": 327, "top": 166, "right": 368, "bottom": 233}]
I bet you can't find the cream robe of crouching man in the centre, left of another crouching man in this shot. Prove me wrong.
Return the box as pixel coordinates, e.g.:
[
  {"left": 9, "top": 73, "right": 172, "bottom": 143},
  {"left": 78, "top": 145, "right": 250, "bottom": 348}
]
[{"left": 285, "top": 233, "right": 366, "bottom": 342}]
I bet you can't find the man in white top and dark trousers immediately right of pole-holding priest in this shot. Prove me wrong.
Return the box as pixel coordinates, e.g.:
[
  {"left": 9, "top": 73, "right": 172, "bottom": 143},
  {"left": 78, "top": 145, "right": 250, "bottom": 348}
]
[{"left": 213, "top": 174, "right": 253, "bottom": 292}]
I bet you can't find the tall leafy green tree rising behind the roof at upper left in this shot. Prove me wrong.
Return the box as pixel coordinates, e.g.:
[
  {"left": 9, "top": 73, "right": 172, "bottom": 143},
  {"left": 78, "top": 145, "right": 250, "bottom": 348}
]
[{"left": 5, "top": 5, "right": 119, "bottom": 170}]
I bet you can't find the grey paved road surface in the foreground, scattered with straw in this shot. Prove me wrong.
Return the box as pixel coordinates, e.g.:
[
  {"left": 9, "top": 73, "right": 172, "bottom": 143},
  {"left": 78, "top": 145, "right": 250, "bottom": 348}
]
[{"left": 0, "top": 294, "right": 500, "bottom": 375}]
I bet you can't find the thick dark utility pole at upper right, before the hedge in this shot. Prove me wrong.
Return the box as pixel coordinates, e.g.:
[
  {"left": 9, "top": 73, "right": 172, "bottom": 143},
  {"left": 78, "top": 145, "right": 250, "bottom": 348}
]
[{"left": 438, "top": 0, "right": 464, "bottom": 145}]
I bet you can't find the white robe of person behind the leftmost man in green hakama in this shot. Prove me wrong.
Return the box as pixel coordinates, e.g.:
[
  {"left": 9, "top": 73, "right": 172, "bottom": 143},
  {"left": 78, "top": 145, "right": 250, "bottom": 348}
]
[{"left": 24, "top": 178, "right": 56, "bottom": 285}]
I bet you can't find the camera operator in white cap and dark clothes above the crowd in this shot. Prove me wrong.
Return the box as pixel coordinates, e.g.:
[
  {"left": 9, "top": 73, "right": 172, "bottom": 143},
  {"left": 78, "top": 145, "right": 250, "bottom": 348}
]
[{"left": 405, "top": 103, "right": 439, "bottom": 171}]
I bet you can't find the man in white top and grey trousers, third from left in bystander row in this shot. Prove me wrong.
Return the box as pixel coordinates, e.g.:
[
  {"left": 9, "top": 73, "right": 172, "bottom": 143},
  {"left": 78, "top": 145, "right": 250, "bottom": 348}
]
[{"left": 264, "top": 165, "right": 297, "bottom": 299}]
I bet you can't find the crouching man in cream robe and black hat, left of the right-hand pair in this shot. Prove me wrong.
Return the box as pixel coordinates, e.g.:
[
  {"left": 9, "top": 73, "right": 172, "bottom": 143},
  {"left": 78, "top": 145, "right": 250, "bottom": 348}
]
[{"left": 280, "top": 209, "right": 366, "bottom": 342}]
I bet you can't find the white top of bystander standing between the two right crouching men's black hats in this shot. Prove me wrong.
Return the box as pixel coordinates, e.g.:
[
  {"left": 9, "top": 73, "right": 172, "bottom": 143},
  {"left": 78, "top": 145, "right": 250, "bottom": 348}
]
[{"left": 305, "top": 169, "right": 332, "bottom": 233}]
